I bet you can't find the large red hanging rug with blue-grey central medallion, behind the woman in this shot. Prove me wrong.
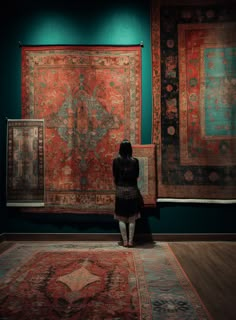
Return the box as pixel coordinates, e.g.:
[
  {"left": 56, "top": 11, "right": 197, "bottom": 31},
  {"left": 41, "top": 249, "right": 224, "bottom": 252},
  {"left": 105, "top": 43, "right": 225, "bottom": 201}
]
[{"left": 22, "top": 46, "right": 141, "bottom": 213}]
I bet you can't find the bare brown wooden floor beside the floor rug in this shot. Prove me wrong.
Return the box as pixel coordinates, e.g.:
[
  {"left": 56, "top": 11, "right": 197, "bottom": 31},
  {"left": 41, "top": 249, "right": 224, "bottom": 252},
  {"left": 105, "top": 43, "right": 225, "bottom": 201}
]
[{"left": 169, "top": 241, "right": 236, "bottom": 320}]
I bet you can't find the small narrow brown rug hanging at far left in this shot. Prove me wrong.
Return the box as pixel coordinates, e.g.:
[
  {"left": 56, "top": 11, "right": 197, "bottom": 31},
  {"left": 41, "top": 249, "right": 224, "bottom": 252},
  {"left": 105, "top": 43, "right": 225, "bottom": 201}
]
[{"left": 6, "top": 119, "right": 44, "bottom": 207}]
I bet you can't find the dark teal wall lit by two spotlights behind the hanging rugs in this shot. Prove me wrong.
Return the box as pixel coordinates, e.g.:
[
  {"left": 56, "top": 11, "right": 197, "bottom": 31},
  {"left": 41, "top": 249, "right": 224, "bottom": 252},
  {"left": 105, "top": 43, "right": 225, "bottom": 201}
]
[{"left": 0, "top": 0, "right": 236, "bottom": 233}]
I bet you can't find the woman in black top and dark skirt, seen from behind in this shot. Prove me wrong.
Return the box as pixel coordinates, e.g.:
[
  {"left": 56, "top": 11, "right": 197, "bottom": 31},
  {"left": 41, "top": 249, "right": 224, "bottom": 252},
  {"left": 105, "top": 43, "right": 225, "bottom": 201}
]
[{"left": 112, "top": 139, "right": 141, "bottom": 247}]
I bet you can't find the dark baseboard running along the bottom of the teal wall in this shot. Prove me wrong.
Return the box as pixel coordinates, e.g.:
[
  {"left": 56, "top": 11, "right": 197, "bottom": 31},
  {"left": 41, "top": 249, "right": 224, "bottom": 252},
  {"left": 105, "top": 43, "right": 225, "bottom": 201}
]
[{"left": 0, "top": 233, "right": 236, "bottom": 242}]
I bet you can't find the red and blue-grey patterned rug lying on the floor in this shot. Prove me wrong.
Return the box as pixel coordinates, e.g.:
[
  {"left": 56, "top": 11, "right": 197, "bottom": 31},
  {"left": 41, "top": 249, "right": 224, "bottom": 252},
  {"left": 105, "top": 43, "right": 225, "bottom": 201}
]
[{"left": 0, "top": 242, "right": 211, "bottom": 320}]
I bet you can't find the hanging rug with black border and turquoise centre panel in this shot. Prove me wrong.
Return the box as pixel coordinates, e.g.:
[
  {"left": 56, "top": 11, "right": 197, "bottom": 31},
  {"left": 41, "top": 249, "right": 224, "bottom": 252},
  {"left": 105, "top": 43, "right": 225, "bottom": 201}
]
[{"left": 152, "top": 1, "right": 236, "bottom": 202}]
